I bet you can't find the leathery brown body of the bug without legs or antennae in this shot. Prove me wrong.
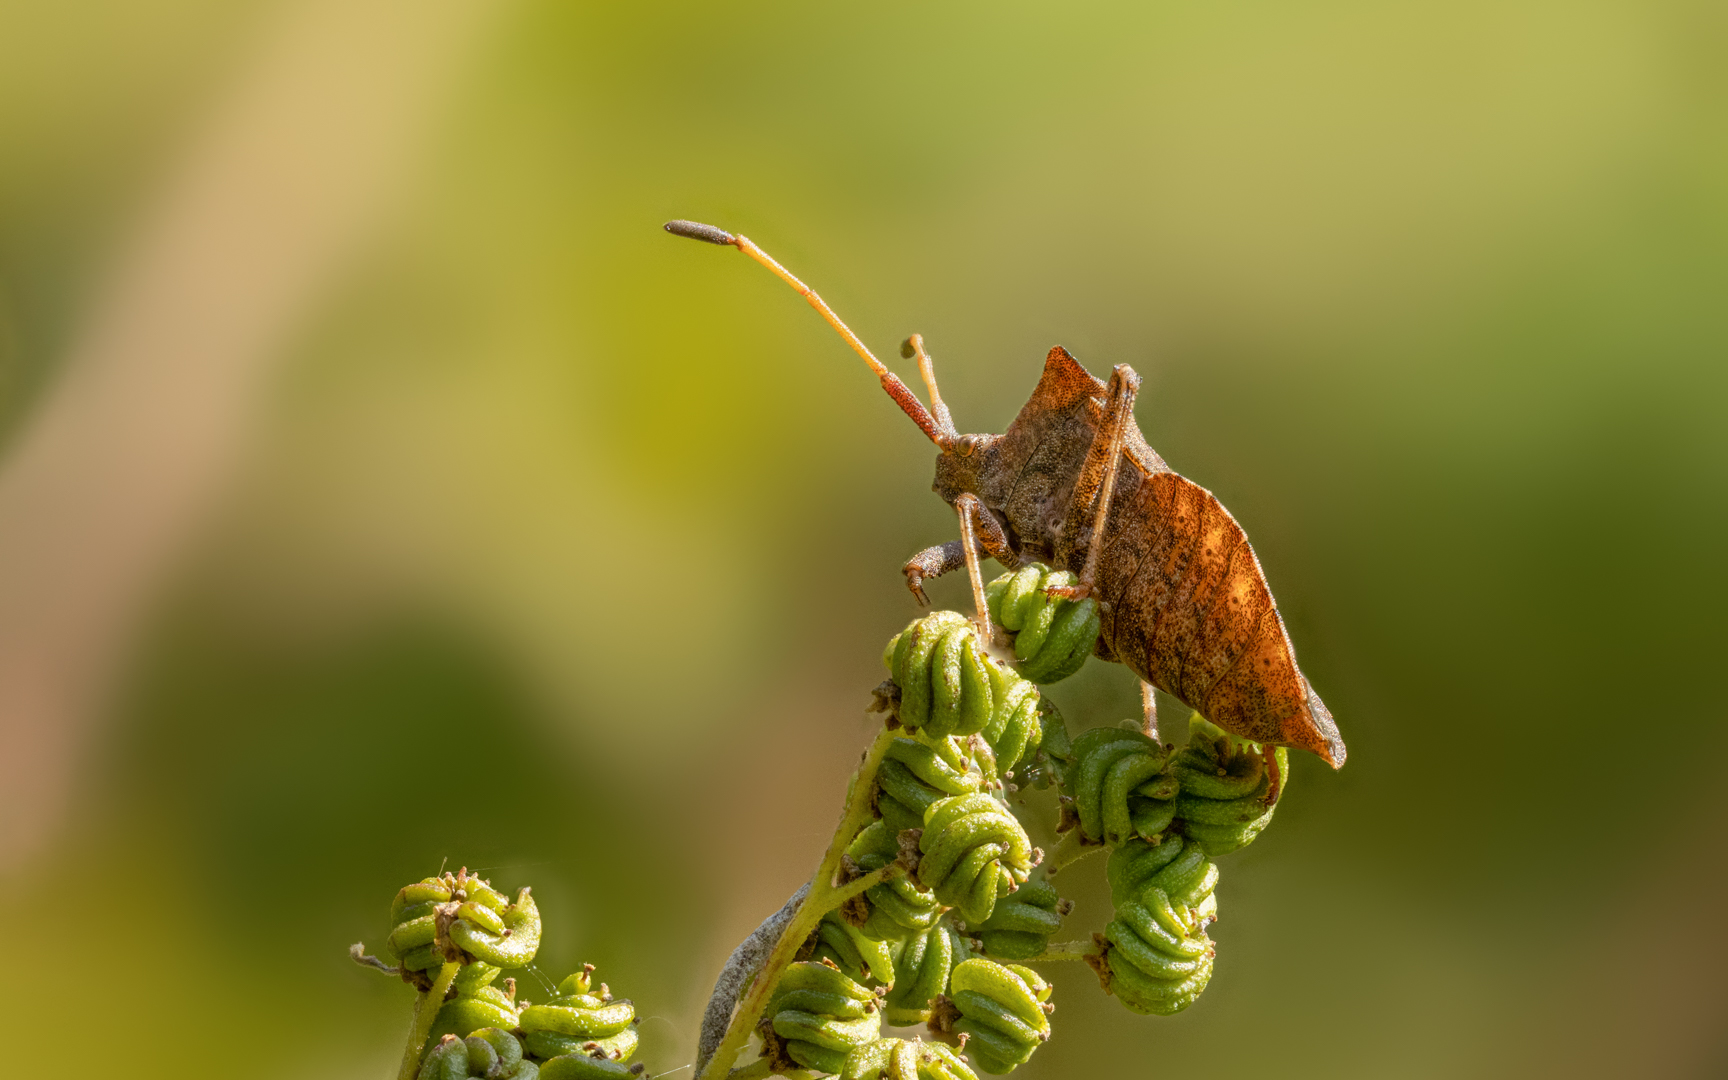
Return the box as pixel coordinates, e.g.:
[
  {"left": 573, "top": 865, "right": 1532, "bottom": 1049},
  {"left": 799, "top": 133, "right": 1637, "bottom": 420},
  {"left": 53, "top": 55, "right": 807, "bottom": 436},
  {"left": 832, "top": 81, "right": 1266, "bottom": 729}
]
[{"left": 935, "top": 346, "right": 1344, "bottom": 769}]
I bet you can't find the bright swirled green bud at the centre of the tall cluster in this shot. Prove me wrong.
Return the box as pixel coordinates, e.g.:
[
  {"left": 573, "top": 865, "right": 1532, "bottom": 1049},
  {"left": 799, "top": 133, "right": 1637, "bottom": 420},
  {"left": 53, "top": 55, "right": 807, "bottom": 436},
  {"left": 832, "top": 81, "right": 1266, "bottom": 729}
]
[{"left": 918, "top": 793, "right": 1042, "bottom": 926}]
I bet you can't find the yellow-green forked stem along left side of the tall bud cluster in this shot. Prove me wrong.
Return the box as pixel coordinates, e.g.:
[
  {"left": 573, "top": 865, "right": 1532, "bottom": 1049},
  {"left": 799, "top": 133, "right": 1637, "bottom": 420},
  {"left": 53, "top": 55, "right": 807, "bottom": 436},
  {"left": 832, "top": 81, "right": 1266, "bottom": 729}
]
[{"left": 694, "top": 726, "right": 897, "bottom": 1080}]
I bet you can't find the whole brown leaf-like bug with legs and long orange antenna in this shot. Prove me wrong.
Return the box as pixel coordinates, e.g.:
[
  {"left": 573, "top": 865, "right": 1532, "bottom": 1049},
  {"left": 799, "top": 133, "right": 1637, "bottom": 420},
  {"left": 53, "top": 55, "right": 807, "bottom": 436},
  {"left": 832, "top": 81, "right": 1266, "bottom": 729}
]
[{"left": 665, "top": 221, "right": 1344, "bottom": 769}]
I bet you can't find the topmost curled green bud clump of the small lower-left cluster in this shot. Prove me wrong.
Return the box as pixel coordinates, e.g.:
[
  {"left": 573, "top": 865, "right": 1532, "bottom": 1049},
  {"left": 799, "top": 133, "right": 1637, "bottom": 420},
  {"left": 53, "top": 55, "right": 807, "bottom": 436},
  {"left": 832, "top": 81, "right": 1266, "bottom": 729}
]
[{"left": 387, "top": 869, "right": 541, "bottom": 988}]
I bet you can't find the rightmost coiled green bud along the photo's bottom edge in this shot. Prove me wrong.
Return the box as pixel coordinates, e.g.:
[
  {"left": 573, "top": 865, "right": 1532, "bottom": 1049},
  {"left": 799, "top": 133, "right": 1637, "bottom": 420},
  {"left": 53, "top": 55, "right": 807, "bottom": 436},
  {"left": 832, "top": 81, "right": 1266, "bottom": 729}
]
[{"left": 930, "top": 959, "right": 1054, "bottom": 1075}]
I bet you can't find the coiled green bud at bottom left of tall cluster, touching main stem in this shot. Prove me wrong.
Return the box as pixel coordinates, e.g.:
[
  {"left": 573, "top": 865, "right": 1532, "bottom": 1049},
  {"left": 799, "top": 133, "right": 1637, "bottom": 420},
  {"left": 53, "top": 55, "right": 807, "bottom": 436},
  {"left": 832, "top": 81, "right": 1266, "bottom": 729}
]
[{"left": 762, "top": 961, "right": 881, "bottom": 1073}]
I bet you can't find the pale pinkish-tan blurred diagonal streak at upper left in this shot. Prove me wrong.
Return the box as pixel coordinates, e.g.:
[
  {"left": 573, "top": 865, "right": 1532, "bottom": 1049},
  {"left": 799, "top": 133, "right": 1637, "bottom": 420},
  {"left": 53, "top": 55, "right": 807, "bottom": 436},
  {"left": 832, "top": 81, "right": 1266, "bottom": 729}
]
[{"left": 0, "top": 0, "right": 501, "bottom": 861}]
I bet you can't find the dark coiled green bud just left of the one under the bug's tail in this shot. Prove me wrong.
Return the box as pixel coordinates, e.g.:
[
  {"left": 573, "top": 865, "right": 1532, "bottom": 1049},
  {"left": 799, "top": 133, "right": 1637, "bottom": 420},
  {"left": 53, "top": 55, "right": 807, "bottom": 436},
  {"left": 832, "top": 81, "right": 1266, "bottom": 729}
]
[{"left": 1063, "top": 727, "right": 1177, "bottom": 845}]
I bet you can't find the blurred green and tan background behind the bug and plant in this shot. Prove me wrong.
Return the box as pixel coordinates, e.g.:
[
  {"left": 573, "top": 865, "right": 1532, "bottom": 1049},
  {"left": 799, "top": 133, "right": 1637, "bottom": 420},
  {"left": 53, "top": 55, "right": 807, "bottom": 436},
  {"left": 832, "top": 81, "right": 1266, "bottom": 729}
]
[{"left": 0, "top": 0, "right": 1728, "bottom": 1080}]
